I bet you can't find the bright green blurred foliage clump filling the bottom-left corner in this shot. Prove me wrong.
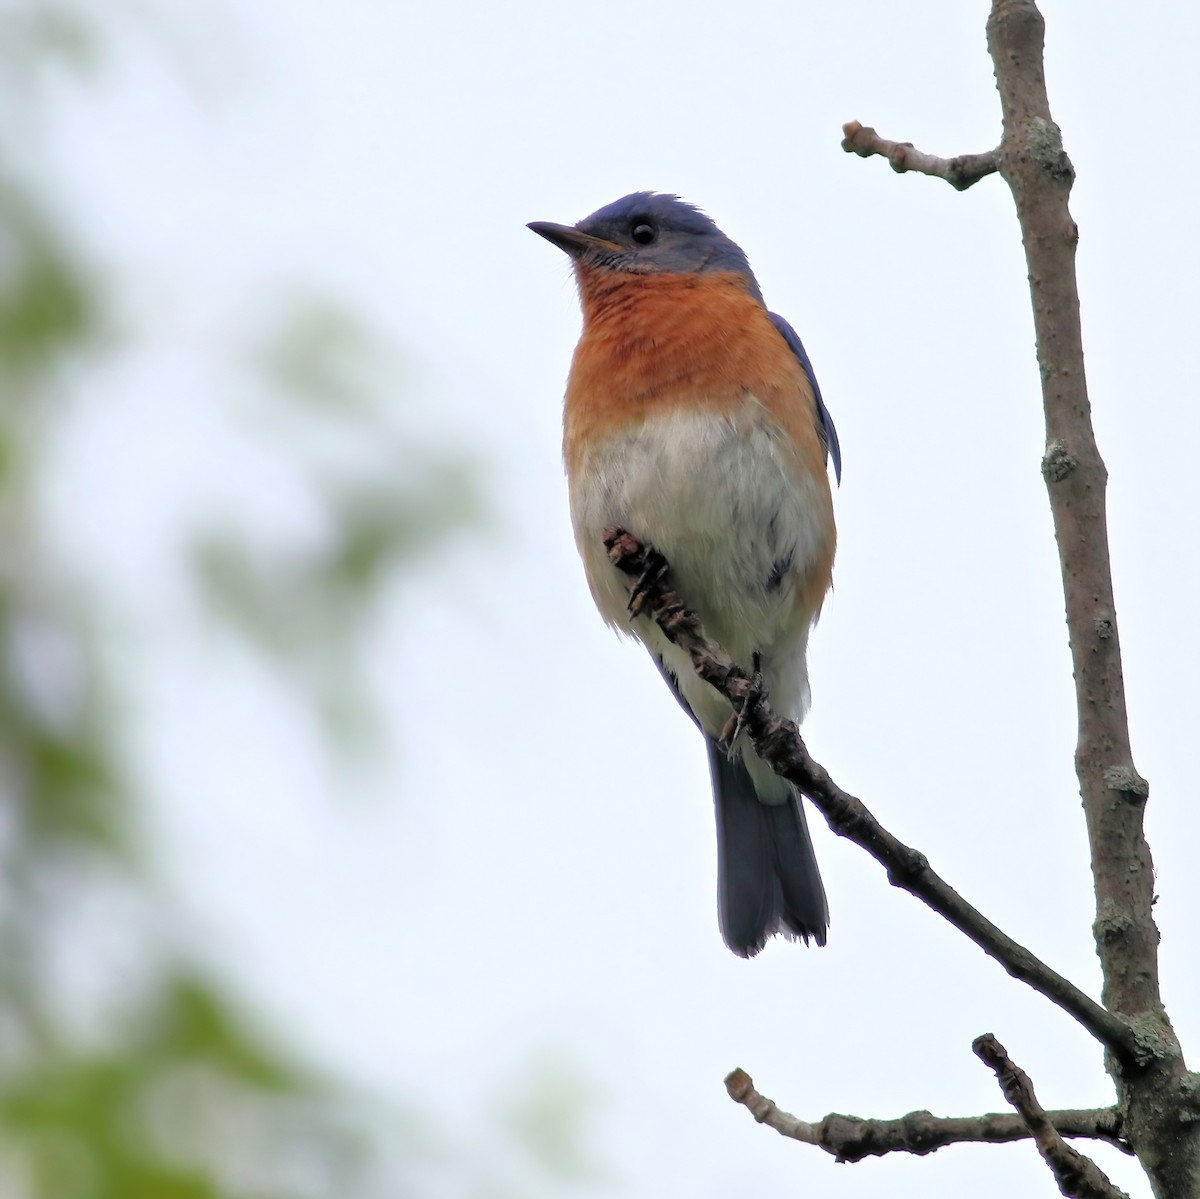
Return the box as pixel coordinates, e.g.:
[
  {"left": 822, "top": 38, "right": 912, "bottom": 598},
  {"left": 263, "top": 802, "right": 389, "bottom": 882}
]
[{"left": 0, "top": 969, "right": 364, "bottom": 1199}]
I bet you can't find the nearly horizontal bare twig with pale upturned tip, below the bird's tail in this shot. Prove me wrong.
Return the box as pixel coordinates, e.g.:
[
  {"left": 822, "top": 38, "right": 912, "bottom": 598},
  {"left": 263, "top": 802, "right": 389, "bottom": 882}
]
[{"left": 725, "top": 1069, "right": 1132, "bottom": 1162}]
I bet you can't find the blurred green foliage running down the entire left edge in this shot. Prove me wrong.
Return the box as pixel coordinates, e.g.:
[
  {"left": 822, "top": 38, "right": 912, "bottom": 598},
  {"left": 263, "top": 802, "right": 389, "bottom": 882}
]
[{"left": 0, "top": 4, "right": 388, "bottom": 1180}]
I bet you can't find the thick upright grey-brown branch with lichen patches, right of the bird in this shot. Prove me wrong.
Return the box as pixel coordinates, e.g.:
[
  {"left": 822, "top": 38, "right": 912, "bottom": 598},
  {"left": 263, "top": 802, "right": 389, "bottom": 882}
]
[{"left": 988, "top": 0, "right": 1200, "bottom": 1197}]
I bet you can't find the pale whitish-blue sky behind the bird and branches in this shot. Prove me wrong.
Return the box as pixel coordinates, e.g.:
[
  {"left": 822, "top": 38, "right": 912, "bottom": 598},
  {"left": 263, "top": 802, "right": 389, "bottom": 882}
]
[{"left": 37, "top": 0, "right": 1200, "bottom": 1199}]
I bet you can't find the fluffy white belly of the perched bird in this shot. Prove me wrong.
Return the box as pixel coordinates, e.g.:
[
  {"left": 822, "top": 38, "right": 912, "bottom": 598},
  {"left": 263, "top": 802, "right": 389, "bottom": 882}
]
[{"left": 571, "top": 398, "right": 827, "bottom": 790}]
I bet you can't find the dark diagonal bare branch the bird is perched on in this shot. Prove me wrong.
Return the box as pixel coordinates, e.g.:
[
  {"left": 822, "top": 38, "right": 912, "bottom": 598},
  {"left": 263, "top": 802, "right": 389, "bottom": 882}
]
[{"left": 604, "top": 529, "right": 1138, "bottom": 1057}]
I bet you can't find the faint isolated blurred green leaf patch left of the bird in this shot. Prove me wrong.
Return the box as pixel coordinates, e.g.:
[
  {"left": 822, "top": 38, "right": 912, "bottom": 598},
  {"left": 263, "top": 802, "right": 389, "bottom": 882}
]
[{"left": 196, "top": 295, "right": 480, "bottom": 745}]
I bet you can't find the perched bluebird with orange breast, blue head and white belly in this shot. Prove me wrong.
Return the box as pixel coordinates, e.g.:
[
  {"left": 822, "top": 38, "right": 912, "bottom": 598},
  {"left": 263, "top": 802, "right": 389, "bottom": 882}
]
[{"left": 528, "top": 192, "right": 841, "bottom": 958}]
